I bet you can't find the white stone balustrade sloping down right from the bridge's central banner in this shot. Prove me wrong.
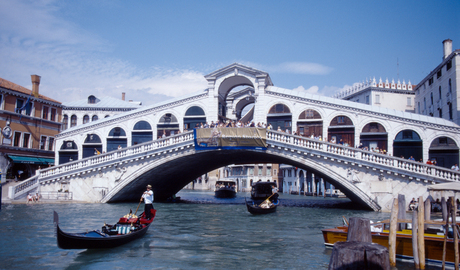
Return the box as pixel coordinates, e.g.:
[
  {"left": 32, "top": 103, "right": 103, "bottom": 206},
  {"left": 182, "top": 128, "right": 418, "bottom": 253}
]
[{"left": 267, "top": 130, "right": 460, "bottom": 181}]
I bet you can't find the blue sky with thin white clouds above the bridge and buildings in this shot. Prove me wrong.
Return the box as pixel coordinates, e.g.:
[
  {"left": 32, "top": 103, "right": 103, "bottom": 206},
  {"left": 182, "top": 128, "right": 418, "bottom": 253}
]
[{"left": 0, "top": 0, "right": 460, "bottom": 105}]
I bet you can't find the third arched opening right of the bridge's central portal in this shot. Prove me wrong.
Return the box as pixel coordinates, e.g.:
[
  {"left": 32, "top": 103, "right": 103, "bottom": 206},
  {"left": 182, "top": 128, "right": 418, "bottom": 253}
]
[{"left": 327, "top": 115, "right": 355, "bottom": 147}]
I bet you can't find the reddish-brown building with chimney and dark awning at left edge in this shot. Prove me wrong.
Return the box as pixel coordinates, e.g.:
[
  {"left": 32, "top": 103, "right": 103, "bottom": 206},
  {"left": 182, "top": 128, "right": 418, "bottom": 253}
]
[{"left": 0, "top": 75, "right": 62, "bottom": 182}]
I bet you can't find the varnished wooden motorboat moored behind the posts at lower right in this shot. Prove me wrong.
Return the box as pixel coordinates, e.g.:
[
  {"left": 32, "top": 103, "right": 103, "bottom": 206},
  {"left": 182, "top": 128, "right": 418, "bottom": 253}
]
[{"left": 322, "top": 217, "right": 460, "bottom": 265}]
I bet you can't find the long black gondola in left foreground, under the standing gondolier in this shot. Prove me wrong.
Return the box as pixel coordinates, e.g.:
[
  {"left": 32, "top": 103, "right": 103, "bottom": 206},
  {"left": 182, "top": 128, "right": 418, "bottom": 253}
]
[{"left": 54, "top": 209, "right": 156, "bottom": 249}]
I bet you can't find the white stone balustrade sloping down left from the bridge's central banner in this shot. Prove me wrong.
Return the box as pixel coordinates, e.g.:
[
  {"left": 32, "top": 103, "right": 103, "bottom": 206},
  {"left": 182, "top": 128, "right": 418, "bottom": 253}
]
[{"left": 8, "top": 131, "right": 193, "bottom": 199}]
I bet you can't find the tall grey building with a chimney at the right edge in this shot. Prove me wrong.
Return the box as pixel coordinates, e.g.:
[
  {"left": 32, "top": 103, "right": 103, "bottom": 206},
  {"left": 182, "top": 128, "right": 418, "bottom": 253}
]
[{"left": 415, "top": 39, "right": 460, "bottom": 125}]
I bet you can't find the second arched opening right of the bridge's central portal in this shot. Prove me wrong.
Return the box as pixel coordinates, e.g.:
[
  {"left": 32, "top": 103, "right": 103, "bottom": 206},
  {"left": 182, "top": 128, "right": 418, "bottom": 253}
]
[{"left": 297, "top": 109, "right": 323, "bottom": 137}]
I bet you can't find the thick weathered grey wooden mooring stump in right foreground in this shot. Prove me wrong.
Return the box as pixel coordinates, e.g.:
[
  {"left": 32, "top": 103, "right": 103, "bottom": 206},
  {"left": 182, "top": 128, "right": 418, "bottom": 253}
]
[{"left": 329, "top": 217, "right": 390, "bottom": 270}]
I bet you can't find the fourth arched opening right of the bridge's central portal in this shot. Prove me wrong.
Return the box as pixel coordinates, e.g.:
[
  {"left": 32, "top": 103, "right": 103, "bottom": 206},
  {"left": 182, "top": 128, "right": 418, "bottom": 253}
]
[{"left": 359, "top": 122, "right": 388, "bottom": 153}]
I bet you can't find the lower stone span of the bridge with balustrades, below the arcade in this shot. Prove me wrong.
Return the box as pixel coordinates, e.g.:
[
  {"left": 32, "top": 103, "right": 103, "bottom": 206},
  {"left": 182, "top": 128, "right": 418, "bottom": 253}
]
[{"left": 9, "top": 130, "right": 460, "bottom": 211}]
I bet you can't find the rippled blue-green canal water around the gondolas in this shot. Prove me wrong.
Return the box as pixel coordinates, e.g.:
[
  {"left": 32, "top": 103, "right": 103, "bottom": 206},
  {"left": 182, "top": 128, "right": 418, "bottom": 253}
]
[{"left": 0, "top": 191, "right": 440, "bottom": 270}]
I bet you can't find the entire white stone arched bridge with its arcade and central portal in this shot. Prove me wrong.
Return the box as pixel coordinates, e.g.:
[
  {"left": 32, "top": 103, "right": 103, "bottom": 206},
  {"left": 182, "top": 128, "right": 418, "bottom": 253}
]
[{"left": 9, "top": 64, "right": 460, "bottom": 211}]
